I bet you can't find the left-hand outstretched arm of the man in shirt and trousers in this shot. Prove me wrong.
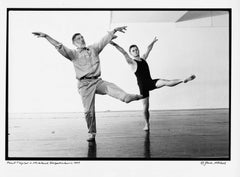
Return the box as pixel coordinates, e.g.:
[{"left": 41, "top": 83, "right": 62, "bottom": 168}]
[{"left": 32, "top": 32, "right": 74, "bottom": 60}]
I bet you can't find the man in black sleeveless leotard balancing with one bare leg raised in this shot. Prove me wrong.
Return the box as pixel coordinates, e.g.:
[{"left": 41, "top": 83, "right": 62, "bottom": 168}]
[{"left": 110, "top": 37, "right": 196, "bottom": 131}]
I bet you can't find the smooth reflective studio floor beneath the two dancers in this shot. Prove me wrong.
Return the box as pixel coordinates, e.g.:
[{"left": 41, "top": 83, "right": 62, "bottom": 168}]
[{"left": 7, "top": 109, "right": 230, "bottom": 160}]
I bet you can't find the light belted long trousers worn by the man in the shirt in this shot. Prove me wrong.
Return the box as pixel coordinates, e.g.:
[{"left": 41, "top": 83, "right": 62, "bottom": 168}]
[{"left": 78, "top": 78, "right": 128, "bottom": 133}]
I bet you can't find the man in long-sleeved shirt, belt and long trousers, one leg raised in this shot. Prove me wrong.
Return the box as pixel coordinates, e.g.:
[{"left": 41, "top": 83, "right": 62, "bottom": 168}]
[{"left": 33, "top": 26, "right": 142, "bottom": 141}]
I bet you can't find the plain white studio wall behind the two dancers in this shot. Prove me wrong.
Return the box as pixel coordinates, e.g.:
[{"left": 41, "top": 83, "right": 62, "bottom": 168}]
[{"left": 9, "top": 12, "right": 229, "bottom": 112}]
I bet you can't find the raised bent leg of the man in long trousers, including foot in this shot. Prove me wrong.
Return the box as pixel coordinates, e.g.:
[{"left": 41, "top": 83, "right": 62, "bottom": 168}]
[{"left": 96, "top": 81, "right": 142, "bottom": 103}]
